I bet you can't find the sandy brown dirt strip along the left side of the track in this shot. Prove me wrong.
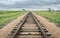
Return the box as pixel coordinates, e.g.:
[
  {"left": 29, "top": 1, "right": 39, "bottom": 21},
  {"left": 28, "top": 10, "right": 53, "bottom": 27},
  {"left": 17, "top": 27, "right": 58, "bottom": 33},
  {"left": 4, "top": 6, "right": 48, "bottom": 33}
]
[{"left": 0, "top": 14, "right": 26, "bottom": 38}]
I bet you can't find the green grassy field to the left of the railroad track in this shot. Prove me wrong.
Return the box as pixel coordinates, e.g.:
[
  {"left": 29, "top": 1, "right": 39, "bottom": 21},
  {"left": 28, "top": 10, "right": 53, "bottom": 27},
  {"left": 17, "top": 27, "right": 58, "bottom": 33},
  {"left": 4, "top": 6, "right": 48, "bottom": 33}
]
[{"left": 0, "top": 11, "right": 25, "bottom": 27}]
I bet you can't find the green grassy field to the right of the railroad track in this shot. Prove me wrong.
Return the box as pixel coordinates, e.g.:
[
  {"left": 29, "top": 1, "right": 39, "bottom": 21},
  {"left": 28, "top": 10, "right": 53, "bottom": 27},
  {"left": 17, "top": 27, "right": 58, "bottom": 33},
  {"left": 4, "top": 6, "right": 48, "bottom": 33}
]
[{"left": 34, "top": 11, "right": 60, "bottom": 26}]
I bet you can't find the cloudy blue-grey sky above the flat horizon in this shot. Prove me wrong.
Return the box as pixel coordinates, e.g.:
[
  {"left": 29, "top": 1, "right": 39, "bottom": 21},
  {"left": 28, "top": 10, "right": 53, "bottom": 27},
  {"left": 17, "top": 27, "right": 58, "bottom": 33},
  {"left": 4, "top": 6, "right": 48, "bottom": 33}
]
[{"left": 0, "top": 0, "right": 60, "bottom": 10}]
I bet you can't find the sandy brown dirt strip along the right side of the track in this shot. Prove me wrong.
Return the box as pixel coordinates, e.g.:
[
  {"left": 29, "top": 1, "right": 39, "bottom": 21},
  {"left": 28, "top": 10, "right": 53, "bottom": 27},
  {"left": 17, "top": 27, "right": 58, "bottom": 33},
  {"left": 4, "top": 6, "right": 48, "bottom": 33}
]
[{"left": 34, "top": 14, "right": 60, "bottom": 38}]
